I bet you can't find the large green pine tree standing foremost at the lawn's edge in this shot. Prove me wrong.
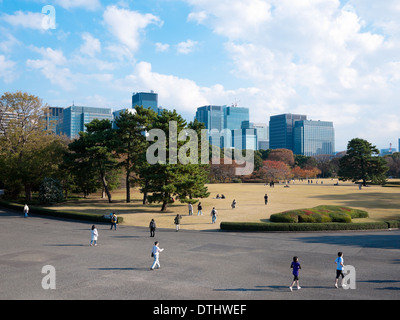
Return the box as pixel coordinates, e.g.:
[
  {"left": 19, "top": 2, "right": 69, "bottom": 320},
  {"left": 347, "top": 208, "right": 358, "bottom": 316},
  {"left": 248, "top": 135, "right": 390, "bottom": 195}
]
[{"left": 141, "top": 110, "right": 209, "bottom": 211}]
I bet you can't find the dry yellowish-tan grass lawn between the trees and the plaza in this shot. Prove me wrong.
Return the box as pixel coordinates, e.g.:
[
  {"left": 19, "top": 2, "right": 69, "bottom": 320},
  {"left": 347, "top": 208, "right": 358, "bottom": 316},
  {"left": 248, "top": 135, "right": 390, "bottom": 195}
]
[{"left": 44, "top": 179, "right": 400, "bottom": 230}]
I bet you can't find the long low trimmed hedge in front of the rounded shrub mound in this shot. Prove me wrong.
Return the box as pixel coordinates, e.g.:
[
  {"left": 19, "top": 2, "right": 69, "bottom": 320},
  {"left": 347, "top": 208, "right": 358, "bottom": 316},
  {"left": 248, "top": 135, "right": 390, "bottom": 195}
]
[{"left": 220, "top": 221, "right": 400, "bottom": 232}]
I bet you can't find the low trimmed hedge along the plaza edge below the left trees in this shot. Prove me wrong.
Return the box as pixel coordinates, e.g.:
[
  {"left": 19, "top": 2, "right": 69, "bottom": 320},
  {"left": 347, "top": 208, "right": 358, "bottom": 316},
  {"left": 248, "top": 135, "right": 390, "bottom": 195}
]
[{"left": 0, "top": 200, "right": 124, "bottom": 223}]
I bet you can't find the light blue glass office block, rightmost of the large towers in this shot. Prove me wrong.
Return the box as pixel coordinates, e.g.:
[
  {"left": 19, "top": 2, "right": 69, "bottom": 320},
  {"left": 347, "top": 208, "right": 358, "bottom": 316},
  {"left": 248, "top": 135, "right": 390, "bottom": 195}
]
[{"left": 293, "top": 120, "right": 335, "bottom": 156}]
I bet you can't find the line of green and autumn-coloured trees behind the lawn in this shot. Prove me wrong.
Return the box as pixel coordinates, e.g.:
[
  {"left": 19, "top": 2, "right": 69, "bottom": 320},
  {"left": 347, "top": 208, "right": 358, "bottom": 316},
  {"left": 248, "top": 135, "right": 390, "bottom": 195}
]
[{"left": 0, "top": 91, "right": 392, "bottom": 211}]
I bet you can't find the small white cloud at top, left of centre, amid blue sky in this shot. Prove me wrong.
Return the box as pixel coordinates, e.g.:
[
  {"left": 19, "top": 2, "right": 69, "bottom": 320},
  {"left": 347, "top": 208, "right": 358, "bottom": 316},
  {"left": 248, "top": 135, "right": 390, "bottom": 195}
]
[{"left": 103, "top": 6, "right": 160, "bottom": 53}]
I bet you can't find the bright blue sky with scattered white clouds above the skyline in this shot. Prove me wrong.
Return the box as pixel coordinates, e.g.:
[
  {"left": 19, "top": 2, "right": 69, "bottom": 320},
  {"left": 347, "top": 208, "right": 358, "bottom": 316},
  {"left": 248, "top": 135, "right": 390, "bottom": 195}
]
[{"left": 0, "top": 0, "right": 400, "bottom": 151}]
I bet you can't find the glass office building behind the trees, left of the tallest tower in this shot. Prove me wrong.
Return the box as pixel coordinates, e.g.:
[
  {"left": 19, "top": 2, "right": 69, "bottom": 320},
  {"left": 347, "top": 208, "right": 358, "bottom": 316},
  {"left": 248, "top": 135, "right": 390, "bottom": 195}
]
[{"left": 57, "top": 105, "right": 113, "bottom": 139}]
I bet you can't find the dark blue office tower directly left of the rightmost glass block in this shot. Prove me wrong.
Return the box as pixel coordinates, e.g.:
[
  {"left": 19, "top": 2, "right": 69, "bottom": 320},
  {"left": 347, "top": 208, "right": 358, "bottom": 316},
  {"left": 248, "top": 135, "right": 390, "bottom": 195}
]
[{"left": 269, "top": 113, "right": 307, "bottom": 151}]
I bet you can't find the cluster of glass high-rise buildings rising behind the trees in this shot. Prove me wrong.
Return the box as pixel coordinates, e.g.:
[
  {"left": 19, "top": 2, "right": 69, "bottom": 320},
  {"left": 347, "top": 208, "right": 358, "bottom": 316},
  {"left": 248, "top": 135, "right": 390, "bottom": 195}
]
[{"left": 39, "top": 91, "right": 335, "bottom": 156}]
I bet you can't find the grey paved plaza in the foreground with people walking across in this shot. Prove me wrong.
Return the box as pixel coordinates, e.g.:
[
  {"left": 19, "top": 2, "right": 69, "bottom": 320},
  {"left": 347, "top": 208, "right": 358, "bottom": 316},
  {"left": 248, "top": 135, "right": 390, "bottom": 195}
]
[{"left": 0, "top": 208, "right": 400, "bottom": 300}]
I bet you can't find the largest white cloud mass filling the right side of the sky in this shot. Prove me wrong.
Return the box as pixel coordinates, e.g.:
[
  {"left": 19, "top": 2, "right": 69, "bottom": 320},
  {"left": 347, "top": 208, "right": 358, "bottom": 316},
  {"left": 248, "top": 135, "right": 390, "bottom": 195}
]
[{"left": 186, "top": 0, "right": 400, "bottom": 148}]
